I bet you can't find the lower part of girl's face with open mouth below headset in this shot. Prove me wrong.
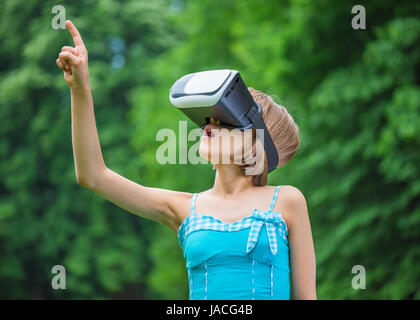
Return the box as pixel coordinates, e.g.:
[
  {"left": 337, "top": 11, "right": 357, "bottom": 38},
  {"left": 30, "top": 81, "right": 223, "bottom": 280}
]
[{"left": 199, "top": 121, "right": 252, "bottom": 164}]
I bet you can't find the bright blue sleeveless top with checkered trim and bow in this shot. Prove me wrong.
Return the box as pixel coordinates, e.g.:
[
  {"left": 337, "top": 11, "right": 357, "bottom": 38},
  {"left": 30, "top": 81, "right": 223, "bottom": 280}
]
[{"left": 178, "top": 186, "right": 290, "bottom": 300}]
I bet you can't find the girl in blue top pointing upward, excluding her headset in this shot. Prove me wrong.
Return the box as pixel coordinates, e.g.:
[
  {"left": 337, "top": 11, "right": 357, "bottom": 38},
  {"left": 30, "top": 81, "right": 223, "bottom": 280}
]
[{"left": 56, "top": 21, "right": 316, "bottom": 300}]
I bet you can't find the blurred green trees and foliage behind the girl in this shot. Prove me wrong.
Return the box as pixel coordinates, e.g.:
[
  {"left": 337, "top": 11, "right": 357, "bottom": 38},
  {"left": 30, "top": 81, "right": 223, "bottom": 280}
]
[{"left": 0, "top": 0, "right": 420, "bottom": 299}]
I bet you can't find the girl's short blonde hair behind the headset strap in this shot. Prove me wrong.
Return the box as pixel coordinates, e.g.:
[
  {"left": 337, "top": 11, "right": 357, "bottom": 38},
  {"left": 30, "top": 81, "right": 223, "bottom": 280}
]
[{"left": 235, "top": 87, "right": 300, "bottom": 186}]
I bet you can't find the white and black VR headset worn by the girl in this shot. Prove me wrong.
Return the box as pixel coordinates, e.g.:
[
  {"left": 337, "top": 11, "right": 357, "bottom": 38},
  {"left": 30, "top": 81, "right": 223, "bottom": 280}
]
[{"left": 169, "top": 69, "right": 279, "bottom": 172}]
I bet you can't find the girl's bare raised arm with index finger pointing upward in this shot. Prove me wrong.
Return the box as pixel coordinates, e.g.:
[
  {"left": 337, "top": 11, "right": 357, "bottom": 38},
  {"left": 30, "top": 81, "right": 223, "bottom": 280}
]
[{"left": 56, "top": 20, "right": 192, "bottom": 232}]
